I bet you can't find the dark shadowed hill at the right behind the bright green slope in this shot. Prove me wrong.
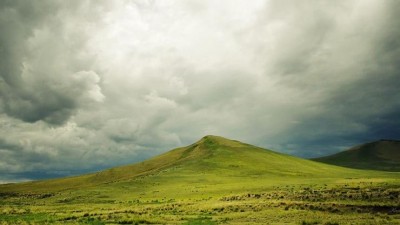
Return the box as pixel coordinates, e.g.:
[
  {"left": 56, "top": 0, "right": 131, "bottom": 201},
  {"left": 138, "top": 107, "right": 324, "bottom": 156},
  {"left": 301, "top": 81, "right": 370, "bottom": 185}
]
[{"left": 313, "top": 140, "right": 400, "bottom": 172}]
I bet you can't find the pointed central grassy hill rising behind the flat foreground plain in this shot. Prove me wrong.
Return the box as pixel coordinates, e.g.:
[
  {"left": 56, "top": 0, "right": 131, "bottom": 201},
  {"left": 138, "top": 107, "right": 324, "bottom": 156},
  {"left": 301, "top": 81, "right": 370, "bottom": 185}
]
[{"left": 0, "top": 136, "right": 356, "bottom": 193}]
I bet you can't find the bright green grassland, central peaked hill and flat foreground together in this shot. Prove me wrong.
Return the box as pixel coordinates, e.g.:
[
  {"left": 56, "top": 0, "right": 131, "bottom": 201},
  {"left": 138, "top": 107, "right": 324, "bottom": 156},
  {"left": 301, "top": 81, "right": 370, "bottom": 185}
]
[{"left": 0, "top": 136, "right": 400, "bottom": 225}]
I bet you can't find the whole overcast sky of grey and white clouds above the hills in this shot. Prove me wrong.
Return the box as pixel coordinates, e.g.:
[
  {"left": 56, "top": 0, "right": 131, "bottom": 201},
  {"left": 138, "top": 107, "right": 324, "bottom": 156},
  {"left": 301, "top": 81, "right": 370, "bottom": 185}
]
[{"left": 0, "top": 0, "right": 400, "bottom": 183}]
